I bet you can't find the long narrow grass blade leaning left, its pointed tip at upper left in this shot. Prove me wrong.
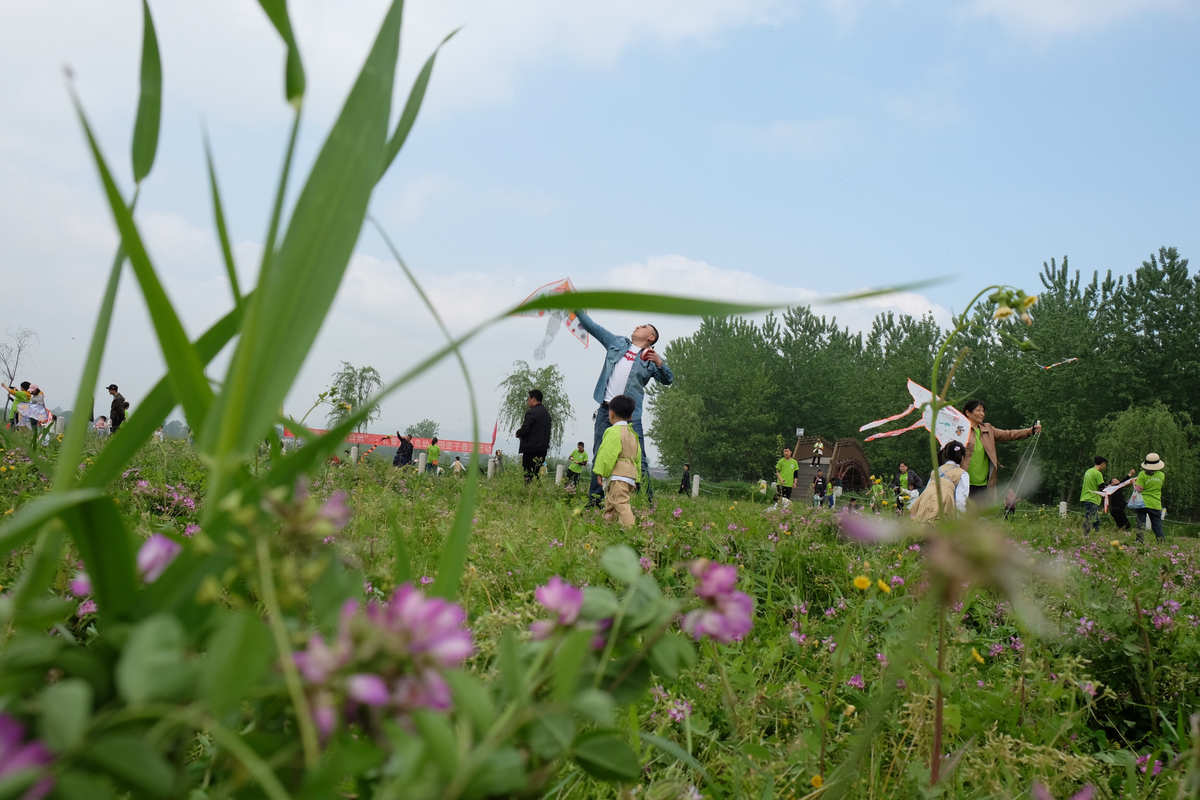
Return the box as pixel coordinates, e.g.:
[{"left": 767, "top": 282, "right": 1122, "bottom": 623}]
[{"left": 71, "top": 91, "right": 212, "bottom": 427}]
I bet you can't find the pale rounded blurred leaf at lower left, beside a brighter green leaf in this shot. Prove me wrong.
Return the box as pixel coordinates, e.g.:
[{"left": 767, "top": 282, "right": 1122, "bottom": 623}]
[{"left": 116, "top": 614, "right": 192, "bottom": 705}]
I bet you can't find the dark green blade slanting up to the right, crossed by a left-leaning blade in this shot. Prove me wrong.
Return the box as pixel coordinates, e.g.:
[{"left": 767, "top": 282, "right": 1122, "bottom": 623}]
[{"left": 79, "top": 295, "right": 252, "bottom": 488}]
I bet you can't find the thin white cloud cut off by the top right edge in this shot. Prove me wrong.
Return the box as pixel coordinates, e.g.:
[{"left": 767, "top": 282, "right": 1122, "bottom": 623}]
[{"left": 968, "top": 0, "right": 1188, "bottom": 36}]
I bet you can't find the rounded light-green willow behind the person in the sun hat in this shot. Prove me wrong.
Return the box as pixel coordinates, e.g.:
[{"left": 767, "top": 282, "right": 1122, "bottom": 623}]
[{"left": 1094, "top": 401, "right": 1200, "bottom": 512}]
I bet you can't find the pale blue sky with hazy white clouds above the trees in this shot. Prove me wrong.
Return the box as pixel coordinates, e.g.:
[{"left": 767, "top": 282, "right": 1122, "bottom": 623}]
[{"left": 0, "top": 0, "right": 1200, "bottom": 462}]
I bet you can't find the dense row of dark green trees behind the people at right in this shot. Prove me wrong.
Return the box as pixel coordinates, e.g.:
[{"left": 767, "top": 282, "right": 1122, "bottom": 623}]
[{"left": 648, "top": 247, "right": 1200, "bottom": 515}]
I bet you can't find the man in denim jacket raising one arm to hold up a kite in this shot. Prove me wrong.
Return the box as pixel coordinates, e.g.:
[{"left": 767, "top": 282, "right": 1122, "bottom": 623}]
[{"left": 575, "top": 311, "right": 674, "bottom": 506}]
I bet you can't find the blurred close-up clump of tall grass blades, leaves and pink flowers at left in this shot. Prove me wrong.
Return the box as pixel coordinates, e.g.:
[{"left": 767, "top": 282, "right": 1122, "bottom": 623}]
[{"left": 0, "top": 0, "right": 945, "bottom": 799}]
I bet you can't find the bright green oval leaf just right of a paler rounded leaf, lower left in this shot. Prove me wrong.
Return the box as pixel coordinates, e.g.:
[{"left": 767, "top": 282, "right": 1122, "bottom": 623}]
[{"left": 200, "top": 610, "right": 274, "bottom": 711}]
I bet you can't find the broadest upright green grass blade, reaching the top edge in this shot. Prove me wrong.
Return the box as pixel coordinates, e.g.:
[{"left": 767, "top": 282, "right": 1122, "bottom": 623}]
[{"left": 202, "top": 0, "right": 401, "bottom": 462}]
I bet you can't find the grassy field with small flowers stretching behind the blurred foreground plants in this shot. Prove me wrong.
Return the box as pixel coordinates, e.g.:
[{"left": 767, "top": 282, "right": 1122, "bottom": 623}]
[{"left": 0, "top": 443, "right": 1200, "bottom": 798}]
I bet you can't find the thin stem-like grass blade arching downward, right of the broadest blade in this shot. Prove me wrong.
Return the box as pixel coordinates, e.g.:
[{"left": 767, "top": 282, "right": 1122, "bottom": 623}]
[{"left": 371, "top": 219, "right": 479, "bottom": 600}]
